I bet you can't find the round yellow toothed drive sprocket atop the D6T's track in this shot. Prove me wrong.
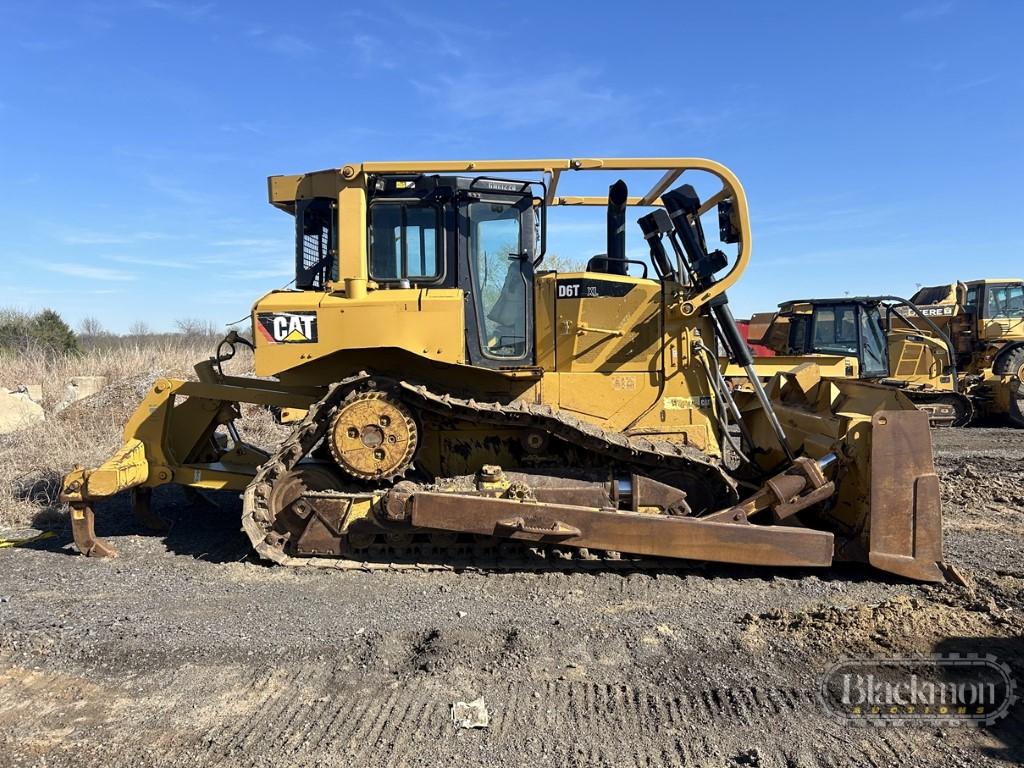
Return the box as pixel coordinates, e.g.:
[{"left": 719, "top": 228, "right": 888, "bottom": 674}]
[{"left": 325, "top": 391, "right": 419, "bottom": 482}]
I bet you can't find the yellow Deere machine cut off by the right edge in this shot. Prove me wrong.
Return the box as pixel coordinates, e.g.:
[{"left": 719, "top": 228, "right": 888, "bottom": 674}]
[{"left": 910, "top": 279, "right": 1024, "bottom": 427}]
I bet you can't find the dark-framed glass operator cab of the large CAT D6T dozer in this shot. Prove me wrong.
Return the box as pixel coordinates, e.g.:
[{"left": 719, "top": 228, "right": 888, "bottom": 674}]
[{"left": 296, "top": 174, "right": 543, "bottom": 368}]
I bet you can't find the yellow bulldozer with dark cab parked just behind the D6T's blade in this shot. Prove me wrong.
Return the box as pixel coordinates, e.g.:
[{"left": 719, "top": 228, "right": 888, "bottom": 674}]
[{"left": 741, "top": 296, "right": 974, "bottom": 427}]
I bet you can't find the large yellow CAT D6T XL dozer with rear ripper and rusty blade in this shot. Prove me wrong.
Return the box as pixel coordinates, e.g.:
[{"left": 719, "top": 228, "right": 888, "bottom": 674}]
[{"left": 62, "top": 158, "right": 946, "bottom": 581}]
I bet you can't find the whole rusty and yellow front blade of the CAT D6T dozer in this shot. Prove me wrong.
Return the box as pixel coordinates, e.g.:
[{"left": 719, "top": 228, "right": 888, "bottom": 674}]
[{"left": 744, "top": 364, "right": 959, "bottom": 582}]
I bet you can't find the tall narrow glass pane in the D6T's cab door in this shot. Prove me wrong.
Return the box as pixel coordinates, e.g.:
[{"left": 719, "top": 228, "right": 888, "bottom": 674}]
[{"left": 469, "top": 202, "right": 529, "bottom": 359}]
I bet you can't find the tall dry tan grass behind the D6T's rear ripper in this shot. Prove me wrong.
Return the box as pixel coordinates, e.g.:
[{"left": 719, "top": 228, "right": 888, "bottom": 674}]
[{"left": 0, "top": 337, "right": 278, "bottom": 528}]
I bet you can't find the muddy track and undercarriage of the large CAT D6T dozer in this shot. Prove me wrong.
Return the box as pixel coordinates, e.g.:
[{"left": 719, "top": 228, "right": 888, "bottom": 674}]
[{"left": 243, "top": 374, "right": 738, "bottom": 568}]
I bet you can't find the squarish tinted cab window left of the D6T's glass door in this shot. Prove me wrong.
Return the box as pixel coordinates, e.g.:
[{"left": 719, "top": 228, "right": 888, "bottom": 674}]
[{"left": 369, "top": 203, "right": 443, "bottom": 283}]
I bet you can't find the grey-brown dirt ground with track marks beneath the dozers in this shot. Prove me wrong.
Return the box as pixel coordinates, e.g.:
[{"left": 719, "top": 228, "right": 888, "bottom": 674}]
[{"left": 0, "top": 429, "right": 1024, "bottom": 768}]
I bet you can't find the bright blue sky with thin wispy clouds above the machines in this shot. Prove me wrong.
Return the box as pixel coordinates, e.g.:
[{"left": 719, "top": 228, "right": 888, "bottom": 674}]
[{"left": 0, "top": 0, "right": 1024, "bottom": 331}]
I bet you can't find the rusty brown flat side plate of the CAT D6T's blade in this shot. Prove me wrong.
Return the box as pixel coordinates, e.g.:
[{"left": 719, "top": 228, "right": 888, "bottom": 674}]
[{"left": 867, "top": 411, "right": 945, "bottom": 582}]
